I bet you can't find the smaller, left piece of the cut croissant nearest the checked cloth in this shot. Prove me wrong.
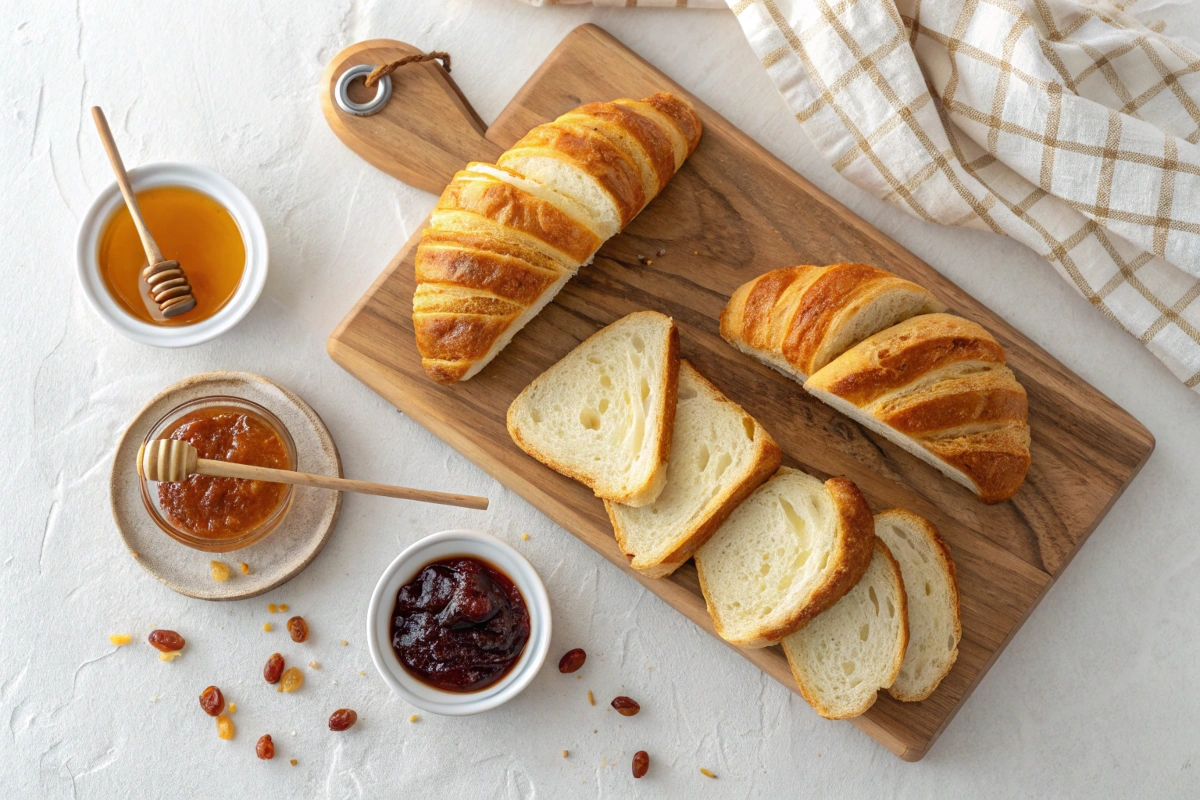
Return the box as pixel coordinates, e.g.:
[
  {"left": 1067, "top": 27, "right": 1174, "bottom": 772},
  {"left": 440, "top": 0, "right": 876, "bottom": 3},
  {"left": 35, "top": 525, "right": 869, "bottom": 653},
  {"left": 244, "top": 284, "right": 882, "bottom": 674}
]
[{"left": 721, "top": 264, "right": 946, "bottom": 383}]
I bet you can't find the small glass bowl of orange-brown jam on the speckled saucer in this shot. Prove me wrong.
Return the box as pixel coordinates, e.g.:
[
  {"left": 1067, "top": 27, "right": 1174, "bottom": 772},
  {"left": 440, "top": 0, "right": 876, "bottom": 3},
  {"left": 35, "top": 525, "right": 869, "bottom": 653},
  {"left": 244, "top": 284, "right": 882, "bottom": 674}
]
[{"left": 138, "top": 396, "right": 296, "bottom": 553}]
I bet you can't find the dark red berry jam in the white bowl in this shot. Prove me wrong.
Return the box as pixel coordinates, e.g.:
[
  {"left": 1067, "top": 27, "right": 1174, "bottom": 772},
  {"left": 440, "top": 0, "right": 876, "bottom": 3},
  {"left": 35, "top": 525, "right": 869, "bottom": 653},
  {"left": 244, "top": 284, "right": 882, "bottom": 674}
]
[{"left": 391, "top": 555, "right": 529, "bottom": 692}]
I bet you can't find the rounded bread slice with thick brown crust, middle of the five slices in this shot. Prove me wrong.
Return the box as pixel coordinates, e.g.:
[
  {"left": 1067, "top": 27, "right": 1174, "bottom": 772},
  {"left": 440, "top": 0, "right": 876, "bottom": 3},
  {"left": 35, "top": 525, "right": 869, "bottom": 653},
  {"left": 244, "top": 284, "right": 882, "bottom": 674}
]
[{"left": 696, "top": 467, "right": 875, "bottom": 648}]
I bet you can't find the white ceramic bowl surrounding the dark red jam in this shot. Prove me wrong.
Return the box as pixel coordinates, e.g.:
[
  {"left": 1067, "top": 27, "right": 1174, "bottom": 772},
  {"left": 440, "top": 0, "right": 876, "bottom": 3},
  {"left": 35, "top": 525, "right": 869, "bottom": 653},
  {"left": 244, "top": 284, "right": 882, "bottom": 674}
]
[{"left": 367, "top": 530, "right": 551, "bottom": 716}]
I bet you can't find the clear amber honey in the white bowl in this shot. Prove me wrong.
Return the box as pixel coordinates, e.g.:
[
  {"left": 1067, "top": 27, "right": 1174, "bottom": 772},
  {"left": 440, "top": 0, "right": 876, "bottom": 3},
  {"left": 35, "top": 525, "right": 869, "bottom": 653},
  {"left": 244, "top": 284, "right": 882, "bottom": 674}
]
[{"left": 96, "top": 186, "right": 246, "bottom": 326}]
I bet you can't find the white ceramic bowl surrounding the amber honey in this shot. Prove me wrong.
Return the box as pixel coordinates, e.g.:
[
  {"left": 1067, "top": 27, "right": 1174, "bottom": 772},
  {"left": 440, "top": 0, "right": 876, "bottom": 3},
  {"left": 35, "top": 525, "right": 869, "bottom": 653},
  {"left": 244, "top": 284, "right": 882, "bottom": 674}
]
[{"left": 76, "top": 162, "right": 266, "bottom": 347}]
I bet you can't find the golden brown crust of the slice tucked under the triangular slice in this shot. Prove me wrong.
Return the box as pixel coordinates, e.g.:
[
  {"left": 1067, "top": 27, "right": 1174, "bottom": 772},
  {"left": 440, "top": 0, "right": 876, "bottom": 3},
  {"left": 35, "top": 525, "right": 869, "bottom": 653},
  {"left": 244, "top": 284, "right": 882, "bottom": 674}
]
[{"left": 605, "top": 359, "right": 784, "bottom": 578}]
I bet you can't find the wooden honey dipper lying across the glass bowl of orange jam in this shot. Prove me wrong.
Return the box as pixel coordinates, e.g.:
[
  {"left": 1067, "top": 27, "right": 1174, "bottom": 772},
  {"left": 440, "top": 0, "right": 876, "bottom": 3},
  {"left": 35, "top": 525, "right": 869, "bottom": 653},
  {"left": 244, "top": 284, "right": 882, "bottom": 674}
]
[{"left": 138, "top": 439, "right": 487, "bottom": 511}]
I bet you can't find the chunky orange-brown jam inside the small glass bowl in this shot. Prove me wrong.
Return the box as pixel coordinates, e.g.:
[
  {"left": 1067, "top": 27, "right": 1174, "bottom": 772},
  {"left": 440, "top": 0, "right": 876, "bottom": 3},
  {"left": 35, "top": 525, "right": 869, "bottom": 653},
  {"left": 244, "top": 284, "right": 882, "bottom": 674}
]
[{"left": 158, "top": 405, "right": 292, "bottom": 539}]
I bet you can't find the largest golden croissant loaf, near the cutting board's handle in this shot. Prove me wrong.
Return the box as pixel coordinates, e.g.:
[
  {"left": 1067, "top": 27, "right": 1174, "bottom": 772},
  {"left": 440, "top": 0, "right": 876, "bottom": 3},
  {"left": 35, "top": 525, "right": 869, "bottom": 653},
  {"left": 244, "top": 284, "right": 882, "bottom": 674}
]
[{"left": 413, "top": 92, "right": 701, "bottom": 383}]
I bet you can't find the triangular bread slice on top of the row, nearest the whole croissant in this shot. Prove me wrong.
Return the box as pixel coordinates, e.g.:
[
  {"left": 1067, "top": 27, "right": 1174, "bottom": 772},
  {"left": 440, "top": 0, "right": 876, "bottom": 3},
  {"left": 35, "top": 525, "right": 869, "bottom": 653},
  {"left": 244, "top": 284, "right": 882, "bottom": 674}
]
[{"left": 508, "top": 311, "right": 679, "bottom": 506}]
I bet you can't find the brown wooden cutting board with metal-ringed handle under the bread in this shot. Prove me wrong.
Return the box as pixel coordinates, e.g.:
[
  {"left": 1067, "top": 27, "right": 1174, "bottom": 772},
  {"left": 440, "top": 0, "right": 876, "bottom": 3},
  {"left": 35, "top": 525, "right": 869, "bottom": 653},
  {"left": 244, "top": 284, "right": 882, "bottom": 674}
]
[{"left": 320, "top": 25, "right": 1154, "bottom": 760}]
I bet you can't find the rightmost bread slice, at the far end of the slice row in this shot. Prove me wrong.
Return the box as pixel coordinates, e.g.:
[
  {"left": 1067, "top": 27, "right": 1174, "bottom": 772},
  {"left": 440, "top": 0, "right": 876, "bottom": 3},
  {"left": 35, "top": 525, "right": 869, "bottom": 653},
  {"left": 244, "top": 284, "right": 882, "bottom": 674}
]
[{"left": 875, "top": 509, "right": 962, "bottom": 703}]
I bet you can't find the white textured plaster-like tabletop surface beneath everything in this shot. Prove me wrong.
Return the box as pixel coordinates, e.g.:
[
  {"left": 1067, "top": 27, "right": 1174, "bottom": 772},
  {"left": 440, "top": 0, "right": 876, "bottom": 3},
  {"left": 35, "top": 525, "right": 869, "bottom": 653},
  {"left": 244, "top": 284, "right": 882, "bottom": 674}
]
[{"left": 0, "top": 0, "right": 1200, "bottom": 798}]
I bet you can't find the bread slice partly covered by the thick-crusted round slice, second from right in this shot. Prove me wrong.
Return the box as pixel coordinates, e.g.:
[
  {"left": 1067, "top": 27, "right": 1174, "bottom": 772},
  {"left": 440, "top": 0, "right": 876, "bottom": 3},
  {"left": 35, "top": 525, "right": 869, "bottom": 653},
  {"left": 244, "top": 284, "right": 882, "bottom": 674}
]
[{"left": 784, "top": 537, "right": 908, "bottom": 720}]
